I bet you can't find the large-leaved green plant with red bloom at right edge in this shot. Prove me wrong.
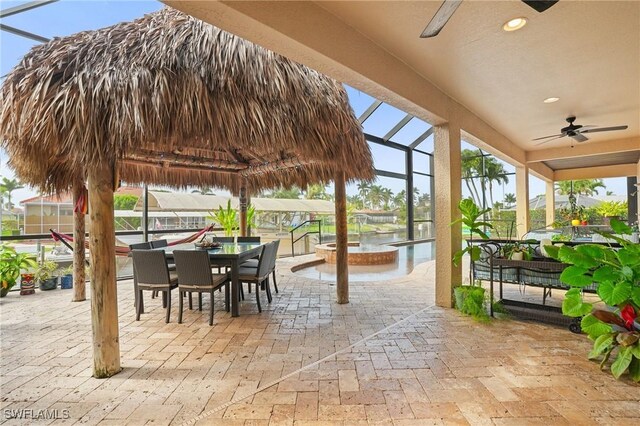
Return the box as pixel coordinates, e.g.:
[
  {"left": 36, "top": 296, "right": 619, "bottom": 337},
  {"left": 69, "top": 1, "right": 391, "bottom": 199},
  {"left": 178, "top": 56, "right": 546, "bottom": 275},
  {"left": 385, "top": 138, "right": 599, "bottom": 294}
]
[{"left": 545, "top": 219, "right": 640, "bottom": 382}]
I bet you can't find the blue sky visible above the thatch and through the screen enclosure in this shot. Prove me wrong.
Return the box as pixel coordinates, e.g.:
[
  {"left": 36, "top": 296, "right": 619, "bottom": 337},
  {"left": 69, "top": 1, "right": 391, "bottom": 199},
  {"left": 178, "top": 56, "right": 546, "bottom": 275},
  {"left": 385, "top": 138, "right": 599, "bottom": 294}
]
[{"left": 0, "top": 0, "right": 626, "bottom": 206}]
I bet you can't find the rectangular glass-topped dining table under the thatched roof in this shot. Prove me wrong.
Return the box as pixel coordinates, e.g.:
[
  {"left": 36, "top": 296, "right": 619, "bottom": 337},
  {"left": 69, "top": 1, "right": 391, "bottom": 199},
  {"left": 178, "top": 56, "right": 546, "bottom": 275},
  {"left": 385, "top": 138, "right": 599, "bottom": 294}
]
[{"left": 152, "top": 243, "right": 264, "bottom": 317}]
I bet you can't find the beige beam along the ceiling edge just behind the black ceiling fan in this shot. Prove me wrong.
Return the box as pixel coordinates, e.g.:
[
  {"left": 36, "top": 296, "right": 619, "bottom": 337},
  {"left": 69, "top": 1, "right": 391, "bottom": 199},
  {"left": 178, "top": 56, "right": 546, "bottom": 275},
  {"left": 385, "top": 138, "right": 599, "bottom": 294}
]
[{"left": 527, "top": 137, "right": 640, "bottom": 163}]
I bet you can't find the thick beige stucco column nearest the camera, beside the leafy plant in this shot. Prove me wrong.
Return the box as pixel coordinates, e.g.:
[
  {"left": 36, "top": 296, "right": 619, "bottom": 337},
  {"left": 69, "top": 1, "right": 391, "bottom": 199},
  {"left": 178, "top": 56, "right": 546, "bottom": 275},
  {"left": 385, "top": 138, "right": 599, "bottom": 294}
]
[{"left": 432, "top": 123, "right": 462, "bottom": 308}]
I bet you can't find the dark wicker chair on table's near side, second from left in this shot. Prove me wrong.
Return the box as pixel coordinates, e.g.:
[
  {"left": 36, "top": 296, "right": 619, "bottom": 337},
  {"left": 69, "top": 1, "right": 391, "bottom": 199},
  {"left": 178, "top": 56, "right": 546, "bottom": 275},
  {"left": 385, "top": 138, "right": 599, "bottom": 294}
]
[{"left": 173, "top": 250, "right": 229, "bottom": 325}]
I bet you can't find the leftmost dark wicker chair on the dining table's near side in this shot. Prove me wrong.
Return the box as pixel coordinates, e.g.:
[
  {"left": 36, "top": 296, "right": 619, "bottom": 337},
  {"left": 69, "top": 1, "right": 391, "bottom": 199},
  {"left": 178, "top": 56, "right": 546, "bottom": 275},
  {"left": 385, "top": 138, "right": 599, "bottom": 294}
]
[{"left": 131, "top": 250, "right": 178, "bottom": 323}]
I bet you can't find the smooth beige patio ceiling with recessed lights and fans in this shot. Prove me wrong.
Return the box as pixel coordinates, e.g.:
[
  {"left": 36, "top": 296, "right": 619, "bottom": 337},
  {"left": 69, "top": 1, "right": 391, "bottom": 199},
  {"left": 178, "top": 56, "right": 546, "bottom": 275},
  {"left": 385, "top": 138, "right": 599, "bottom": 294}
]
[{"left": 317, "top": 0, "right": 640, "bottom": 150}]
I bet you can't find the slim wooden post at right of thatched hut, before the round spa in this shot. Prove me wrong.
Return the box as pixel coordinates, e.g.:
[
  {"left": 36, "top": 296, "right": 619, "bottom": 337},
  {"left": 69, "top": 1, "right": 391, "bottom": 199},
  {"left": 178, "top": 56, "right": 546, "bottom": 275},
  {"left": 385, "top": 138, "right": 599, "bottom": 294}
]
[{"left": 335, "top": 172, "right": 349, "bottom": 304}]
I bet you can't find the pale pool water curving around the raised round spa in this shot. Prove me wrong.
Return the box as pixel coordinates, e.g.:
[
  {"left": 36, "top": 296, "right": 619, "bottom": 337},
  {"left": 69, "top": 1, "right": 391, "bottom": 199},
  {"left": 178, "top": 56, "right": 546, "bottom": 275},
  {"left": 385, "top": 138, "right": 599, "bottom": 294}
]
[{"left": 295, "top": 242, "right": 435, "bottom": 282}]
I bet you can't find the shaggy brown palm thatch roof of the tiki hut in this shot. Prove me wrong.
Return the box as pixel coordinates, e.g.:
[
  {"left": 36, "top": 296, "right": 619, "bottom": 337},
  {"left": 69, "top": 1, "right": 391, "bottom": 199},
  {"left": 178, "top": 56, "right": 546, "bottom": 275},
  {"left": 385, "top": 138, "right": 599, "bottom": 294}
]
[{"left": 0, "top": 7, "right": 374, "bottom": 192}]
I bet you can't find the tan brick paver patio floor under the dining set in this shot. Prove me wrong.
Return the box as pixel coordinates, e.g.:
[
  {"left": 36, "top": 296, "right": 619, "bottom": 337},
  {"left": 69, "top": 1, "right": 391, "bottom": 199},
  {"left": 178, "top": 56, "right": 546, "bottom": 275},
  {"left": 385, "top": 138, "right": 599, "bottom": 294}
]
[{"left": 0, "top": 258, "right": 640, "bottom": 425}]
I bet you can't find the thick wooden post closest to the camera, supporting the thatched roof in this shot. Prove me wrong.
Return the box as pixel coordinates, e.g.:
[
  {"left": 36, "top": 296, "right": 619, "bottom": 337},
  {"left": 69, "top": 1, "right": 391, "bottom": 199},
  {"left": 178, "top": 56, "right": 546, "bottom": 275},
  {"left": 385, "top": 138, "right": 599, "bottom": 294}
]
[{"left": 89, "top": 164, "right": 120, "bottom": 378}]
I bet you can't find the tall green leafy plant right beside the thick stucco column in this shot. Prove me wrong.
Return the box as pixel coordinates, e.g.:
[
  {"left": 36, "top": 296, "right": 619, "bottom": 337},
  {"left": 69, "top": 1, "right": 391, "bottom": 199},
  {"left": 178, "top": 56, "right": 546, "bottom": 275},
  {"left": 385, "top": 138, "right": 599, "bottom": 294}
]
[{"left": 451, "top": 198, "right": 493, "bottom": 319}]
